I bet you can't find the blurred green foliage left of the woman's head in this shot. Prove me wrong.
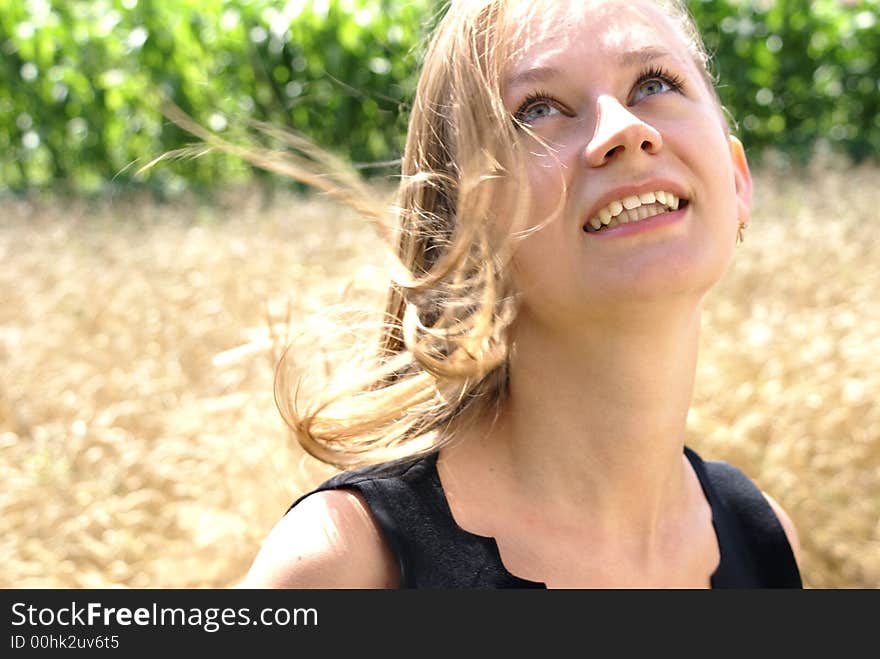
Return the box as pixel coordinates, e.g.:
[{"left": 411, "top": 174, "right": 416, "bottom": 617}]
[{"left": 0, "top": 0, "right": 430, "bottom": 191}]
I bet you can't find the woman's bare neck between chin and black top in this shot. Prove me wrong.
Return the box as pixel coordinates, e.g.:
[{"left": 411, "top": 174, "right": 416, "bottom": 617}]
[{"left": 474, "top": 306, "right": 700, "bottom": 539}]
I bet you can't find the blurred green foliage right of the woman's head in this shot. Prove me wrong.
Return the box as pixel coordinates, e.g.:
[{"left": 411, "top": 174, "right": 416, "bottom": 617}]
[{"left": 689, "top": 0, "right": 880, "bottom": 162}]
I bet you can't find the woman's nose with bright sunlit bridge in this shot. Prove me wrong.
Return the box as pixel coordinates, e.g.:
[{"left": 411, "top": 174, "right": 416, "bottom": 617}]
[{"left": 584, "top": 96, "right": 663, "bottom": 167}]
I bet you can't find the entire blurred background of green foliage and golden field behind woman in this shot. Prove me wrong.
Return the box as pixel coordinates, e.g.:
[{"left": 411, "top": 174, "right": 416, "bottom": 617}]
[{"left": 0, "top": 0, "right": 880, "bottom": 588}]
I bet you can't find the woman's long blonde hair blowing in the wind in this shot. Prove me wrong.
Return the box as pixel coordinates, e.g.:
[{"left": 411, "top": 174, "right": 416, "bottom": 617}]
[{"left": 165, "top": 0, "right": 714, "bottom": 468}]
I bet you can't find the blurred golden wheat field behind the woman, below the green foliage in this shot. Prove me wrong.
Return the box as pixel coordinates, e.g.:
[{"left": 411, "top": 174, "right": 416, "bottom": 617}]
[{"left": 0, "top": 167, "right": 880, "bottom": 588}]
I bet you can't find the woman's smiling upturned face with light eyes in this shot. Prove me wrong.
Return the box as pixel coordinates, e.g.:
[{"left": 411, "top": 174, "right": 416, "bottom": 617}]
[{"left": 503, "top": 0, "right": 751, "bottom": 327}]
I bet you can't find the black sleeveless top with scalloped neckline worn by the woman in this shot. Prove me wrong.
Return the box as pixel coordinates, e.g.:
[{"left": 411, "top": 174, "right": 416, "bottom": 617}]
[{"left": 290, "top": 447, "right": 802, "bottom": 588}]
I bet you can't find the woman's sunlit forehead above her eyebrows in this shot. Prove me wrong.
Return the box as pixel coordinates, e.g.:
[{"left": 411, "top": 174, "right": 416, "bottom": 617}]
[{"left": 508, "top": 0, "right": 692, "bottom": 78}]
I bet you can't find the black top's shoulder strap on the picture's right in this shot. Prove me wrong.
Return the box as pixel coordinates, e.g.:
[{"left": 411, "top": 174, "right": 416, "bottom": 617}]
[{"left": 685, "top": 448, "right": 802, "bottom": 588}]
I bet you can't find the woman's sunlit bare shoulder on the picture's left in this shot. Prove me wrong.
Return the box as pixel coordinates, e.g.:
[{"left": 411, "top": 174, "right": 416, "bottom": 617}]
[{"left": 238, "top": 490, "right": 399, "bottom": 588}]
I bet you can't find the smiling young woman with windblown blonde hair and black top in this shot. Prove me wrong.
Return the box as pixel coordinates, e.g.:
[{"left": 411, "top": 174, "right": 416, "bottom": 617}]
[{"left": 241, "top": 0, "right": 801, "bottom": 588}]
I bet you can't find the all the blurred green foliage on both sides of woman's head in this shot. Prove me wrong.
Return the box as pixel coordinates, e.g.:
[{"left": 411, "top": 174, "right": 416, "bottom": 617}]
[{"left": 0, "top": 0, "right": 880, "bottom": 196}]
